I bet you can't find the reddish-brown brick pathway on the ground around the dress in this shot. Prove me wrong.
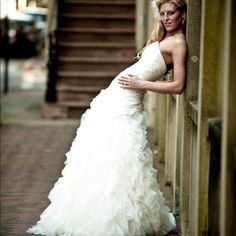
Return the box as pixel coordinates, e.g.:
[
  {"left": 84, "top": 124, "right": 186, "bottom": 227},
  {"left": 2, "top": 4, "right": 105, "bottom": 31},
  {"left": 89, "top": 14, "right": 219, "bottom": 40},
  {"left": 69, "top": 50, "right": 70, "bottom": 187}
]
[{"left": 1, "top": 124, "right": 177, "bottom": 236}]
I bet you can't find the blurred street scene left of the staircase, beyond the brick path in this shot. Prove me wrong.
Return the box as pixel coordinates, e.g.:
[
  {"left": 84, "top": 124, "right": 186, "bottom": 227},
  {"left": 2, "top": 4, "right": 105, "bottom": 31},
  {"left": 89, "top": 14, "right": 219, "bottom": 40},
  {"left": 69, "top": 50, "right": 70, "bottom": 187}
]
[{"left": 0, "top": 0, "right": 48, "bottom": 122}]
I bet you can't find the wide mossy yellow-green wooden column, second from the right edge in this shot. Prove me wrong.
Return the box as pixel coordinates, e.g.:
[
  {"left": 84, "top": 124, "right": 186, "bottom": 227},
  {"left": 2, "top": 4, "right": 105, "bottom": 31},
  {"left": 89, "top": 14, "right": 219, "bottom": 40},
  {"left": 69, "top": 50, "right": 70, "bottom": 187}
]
[{"left": 196, "top": 0, "right": 225, "bottom": 233}]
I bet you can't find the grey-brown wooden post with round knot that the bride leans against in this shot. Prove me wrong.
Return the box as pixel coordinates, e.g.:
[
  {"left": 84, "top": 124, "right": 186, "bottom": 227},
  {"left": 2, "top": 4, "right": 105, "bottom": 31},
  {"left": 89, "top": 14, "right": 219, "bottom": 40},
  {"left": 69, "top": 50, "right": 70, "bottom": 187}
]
[{"left": 180, "top": 0, "right": 201, "bottom": 236}]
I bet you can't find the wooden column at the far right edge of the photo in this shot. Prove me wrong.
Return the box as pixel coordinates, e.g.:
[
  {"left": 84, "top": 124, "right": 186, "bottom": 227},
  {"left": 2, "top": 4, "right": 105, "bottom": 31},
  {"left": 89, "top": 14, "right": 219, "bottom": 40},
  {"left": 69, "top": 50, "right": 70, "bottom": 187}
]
[{"left": 220, "top": 0, "right": 236, "bottom": 236}]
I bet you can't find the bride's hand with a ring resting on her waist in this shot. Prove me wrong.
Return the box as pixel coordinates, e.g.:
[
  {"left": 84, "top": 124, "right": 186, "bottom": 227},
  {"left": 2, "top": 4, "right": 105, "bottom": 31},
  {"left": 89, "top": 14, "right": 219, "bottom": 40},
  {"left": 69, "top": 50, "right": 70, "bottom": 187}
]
[{"left": 118, "top": 74, "right": 145, "bottom": 90}]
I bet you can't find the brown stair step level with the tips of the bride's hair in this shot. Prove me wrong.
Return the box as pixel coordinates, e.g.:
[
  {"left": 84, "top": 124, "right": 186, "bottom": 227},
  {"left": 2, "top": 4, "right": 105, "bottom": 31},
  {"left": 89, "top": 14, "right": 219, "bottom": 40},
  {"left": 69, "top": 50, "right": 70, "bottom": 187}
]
[{"left": 58, "top": 42, "right": 136, "bottom": 57}]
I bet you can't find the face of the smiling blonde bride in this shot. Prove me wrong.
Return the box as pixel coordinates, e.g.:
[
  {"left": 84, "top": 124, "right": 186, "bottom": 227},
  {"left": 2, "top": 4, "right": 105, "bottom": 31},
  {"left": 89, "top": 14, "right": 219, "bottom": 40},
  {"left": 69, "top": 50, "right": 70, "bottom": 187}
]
[{"left": 160, "top": 3, "right": 184, "bottom": 33}]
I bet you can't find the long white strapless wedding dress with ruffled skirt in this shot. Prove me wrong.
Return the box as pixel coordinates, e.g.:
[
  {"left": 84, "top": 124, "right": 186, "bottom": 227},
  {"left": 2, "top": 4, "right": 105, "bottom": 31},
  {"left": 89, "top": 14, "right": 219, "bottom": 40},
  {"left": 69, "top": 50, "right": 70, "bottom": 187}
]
[{"left": 27, "top": 42, "right": 176, "bottom": 236}]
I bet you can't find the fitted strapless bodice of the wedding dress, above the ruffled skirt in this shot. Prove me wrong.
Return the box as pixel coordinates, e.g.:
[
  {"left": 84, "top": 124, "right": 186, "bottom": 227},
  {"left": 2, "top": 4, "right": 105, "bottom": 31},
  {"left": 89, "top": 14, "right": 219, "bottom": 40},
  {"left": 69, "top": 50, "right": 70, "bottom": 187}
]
[{"left": 87, "top": 42, "right": 167, "bottom": 117}]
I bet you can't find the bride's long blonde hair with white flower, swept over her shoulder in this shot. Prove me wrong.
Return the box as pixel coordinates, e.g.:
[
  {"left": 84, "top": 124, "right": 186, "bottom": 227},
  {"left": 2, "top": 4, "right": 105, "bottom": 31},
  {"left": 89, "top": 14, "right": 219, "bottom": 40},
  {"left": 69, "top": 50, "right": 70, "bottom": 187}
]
[{"left": 136, "top": 0, "right": 187, "bottom": 59}]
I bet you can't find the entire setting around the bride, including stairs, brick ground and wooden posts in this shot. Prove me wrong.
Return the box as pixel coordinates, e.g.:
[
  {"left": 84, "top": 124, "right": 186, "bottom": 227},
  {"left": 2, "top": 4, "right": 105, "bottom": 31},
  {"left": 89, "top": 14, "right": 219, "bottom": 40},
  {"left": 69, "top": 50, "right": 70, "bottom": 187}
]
[{"left": 0, "top": 0, "right": 236, "bottom": 236}]
